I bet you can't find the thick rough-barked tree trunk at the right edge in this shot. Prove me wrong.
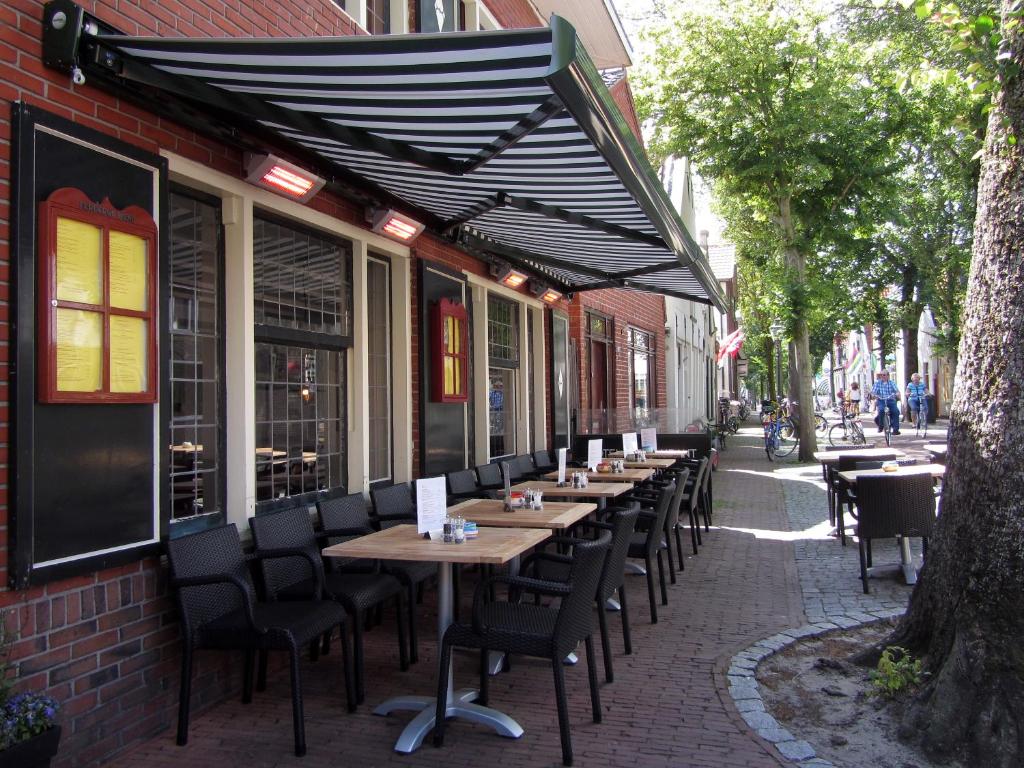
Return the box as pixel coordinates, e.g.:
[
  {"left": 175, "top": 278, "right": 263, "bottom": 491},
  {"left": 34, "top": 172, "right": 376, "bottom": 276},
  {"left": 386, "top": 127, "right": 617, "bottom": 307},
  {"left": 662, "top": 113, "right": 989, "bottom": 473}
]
[{"left": 893, "top": 9, "right": 1024, "bottom": 768}]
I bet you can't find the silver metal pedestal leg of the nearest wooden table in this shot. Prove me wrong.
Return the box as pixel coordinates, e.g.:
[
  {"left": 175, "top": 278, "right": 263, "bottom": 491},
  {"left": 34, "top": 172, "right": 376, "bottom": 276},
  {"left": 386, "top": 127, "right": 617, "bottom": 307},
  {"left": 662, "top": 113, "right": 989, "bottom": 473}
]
[{"left": 374, "top": 561, "right": 522, "bottom": 754}]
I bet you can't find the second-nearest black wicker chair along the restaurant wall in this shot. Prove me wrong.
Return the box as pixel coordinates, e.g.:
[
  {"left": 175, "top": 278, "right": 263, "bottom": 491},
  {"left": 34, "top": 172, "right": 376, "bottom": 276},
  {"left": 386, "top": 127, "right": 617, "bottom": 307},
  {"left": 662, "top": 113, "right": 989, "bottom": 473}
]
[{"left": 249, "top": 496, "right": 409, "bottom": 703}]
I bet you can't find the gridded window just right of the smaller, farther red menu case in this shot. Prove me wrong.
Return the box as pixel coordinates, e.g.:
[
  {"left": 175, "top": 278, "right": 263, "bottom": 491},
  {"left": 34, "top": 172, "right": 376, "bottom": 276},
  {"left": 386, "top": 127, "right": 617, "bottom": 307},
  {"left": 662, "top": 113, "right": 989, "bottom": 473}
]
[{"left": 487, "top": 295, "right": 519, "bottom": 459}]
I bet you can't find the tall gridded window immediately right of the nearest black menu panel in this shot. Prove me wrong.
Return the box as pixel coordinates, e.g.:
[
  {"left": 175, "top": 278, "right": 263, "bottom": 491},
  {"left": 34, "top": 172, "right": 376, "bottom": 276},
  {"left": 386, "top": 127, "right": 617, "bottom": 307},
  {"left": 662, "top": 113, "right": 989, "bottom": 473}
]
[{"left": 165, "top": 190, "right": 224, "bottom": 528}]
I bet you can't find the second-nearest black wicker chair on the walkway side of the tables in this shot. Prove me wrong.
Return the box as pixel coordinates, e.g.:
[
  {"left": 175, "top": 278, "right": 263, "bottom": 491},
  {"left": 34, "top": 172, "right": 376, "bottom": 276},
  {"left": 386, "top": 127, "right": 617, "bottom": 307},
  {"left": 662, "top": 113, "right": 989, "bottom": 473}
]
[{"left": 520, "top": 504, "right": 640, "bottom": 683}]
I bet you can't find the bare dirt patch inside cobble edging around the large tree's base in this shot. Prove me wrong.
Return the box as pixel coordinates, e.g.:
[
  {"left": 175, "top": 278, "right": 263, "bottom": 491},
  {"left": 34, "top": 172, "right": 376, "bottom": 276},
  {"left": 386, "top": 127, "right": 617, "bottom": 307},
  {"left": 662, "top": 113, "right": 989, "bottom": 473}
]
[{"left": 757, "top": 622, "right": 967, "bottom": 768}]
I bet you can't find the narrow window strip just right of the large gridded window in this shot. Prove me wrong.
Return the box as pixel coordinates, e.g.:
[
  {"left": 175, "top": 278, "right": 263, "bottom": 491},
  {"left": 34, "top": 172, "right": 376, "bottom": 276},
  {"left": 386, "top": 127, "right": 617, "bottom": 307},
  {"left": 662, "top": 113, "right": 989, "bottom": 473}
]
[{"left": 367, "top": 258, "right": 391, "bottom": 482}]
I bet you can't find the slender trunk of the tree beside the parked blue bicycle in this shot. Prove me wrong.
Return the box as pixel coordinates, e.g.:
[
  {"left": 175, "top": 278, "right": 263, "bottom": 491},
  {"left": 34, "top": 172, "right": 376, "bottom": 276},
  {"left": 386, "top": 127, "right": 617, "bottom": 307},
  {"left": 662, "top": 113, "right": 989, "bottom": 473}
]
[{"left": 778, "top": 196, "right": 818, "bottom": 462}]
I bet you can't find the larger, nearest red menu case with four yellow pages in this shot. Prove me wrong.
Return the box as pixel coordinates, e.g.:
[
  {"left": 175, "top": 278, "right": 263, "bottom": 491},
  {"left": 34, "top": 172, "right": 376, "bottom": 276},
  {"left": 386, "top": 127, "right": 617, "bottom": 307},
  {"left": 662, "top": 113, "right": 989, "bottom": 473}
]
[{"left": 37, "top": 187, "right": 157, "bottom": 402}]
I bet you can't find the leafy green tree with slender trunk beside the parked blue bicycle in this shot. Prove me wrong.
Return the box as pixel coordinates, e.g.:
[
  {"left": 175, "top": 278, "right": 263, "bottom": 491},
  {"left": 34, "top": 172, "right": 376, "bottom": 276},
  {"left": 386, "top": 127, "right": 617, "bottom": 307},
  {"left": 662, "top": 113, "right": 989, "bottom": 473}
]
[{"left": 638, "top": 0, "right": 903, "bottom": 461}]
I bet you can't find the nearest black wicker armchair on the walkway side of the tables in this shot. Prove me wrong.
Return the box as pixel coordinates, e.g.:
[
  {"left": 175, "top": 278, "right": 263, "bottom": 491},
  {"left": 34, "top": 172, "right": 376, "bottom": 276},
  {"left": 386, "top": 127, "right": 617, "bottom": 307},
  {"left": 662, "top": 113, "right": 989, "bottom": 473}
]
[{"left": 434, "top": 531, "right": 611, "bottom": 765}]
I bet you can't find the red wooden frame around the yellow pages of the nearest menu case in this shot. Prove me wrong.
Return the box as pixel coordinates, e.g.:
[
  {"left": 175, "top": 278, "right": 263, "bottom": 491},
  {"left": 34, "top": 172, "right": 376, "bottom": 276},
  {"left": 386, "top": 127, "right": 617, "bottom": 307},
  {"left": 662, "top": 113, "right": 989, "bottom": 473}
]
[{"left": 36, "top": 187, "right": 159, "bottom": 403}]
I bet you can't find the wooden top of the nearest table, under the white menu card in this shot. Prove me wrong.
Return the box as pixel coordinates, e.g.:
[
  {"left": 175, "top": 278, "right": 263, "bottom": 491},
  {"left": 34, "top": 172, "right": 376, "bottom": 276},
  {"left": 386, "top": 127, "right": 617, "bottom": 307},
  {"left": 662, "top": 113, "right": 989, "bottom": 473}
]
[{"left": 323, "top": 525, "right": 551, "bottom": 565}]
